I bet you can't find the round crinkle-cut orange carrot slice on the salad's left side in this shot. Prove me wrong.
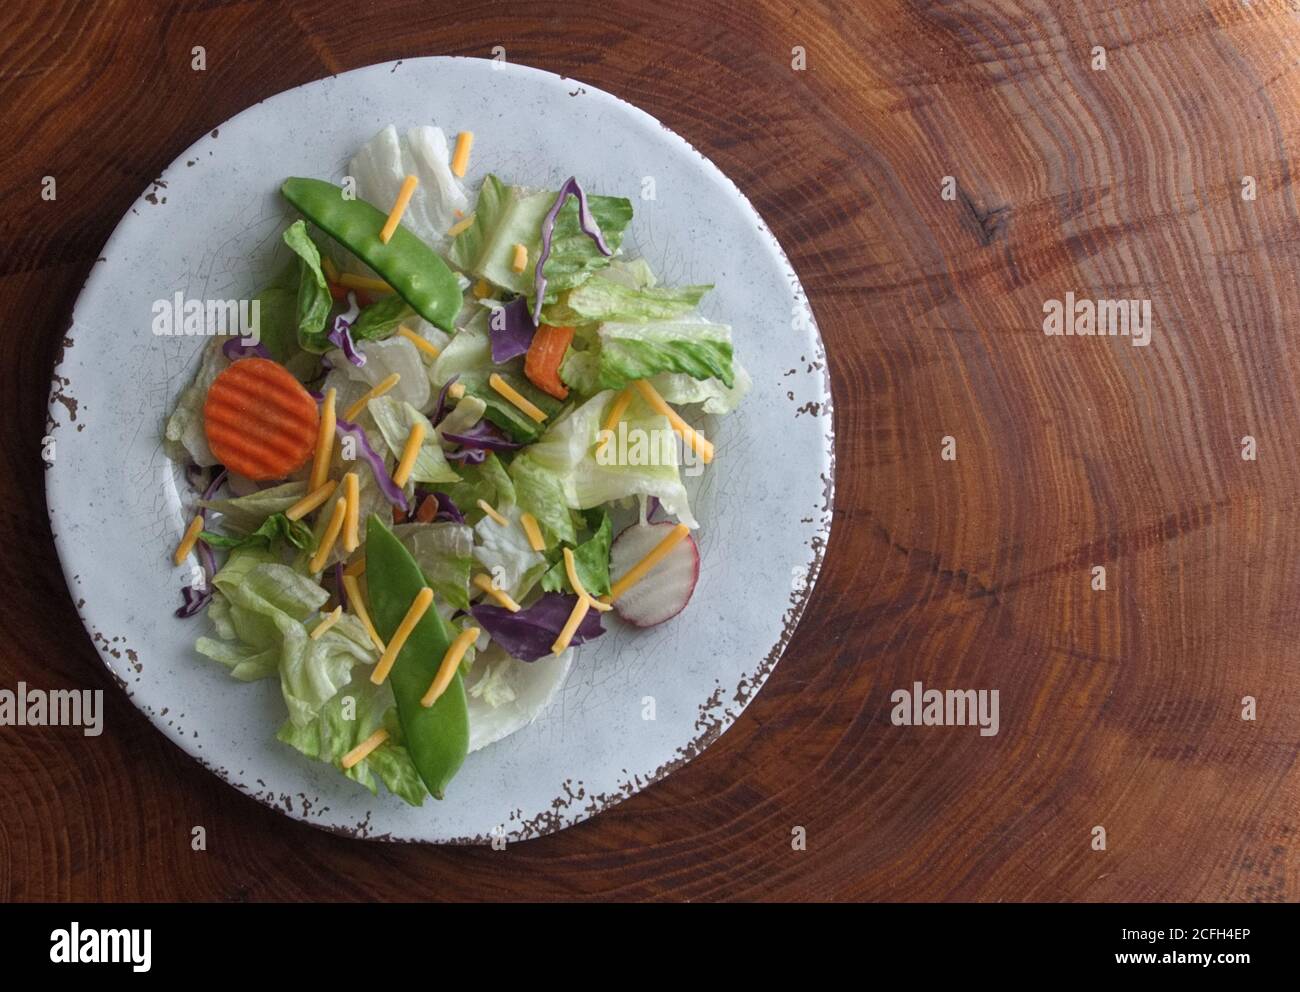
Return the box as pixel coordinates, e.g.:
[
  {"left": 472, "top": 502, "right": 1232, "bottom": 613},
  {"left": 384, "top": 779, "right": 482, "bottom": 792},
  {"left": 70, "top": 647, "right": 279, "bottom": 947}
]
[{"left": 203, "top": 358, "right": 320, "bottom": 481}]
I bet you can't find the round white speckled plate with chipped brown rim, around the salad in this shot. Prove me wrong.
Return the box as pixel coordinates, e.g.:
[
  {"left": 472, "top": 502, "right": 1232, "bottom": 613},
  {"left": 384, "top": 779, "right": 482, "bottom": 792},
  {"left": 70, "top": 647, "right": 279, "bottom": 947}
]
[{"left": 47, "top": 59, "right": 833, "bottom": 842}]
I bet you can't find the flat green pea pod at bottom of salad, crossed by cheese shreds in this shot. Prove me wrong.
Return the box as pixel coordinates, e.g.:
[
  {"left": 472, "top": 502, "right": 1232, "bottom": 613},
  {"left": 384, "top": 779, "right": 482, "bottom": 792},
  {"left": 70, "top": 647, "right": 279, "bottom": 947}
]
[{"left": 365, "top": 514, "right": 469, "bottom": 800}]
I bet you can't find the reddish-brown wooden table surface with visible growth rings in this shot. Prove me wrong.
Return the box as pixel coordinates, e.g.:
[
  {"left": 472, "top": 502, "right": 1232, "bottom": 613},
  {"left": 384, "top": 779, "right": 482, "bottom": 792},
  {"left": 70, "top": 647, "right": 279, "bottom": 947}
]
[{"left": 0, "top": 0, "right": 1300, "bottom": 901}]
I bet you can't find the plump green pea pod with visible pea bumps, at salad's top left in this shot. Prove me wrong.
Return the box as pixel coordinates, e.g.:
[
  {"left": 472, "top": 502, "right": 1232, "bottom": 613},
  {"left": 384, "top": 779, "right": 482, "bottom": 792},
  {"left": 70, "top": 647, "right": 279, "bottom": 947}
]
[{"left": 280, "top": 178, "right": 462, "bottom": 332}]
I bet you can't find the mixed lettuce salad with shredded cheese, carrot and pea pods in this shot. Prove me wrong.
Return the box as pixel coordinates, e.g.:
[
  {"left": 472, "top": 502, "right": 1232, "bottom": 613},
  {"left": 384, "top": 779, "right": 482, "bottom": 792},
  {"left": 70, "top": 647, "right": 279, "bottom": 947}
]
[{"left": 165, "top": 126, "right": 749, "bottom": 805}]
